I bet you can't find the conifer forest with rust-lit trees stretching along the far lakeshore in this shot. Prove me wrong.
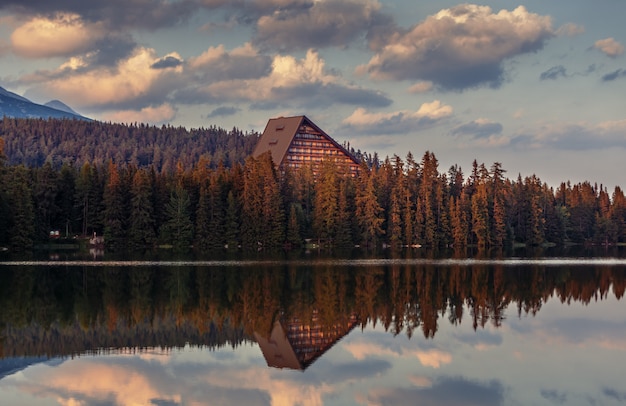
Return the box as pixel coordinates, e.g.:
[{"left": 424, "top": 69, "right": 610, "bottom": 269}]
[{"left": 0, "top": 118, "right": 626, "bottom": 250}]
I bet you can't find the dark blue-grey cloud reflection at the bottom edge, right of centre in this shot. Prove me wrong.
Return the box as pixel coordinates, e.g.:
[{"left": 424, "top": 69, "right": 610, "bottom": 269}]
[{"left": 367, "top": 377, "right": 504, "bottom": 406}]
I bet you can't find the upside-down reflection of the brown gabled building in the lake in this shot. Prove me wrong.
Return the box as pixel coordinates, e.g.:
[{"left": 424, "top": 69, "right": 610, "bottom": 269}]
[{"left": 254, "top": 312, "right": 357, "bottom": 370}]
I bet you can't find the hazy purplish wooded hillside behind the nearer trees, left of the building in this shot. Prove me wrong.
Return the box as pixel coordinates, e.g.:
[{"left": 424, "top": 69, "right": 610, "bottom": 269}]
[{"left": 0, "top": 117, "right": 258, "bottom": 171}]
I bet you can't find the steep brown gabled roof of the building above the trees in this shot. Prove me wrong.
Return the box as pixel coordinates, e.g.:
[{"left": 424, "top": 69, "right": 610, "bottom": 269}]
[{"left": 252, "top": 116, "right": 359, "bottom": 165}]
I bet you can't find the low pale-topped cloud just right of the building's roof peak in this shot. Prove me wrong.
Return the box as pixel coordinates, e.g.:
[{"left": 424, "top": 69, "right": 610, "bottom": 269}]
[{"left": 342, "top": 100, "right": 453, "bottom": 134}]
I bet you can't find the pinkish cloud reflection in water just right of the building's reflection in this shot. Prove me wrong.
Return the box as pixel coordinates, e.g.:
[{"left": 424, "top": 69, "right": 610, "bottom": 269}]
[{"left": 345, "top": 342, "right": 452, "bottom": 368}]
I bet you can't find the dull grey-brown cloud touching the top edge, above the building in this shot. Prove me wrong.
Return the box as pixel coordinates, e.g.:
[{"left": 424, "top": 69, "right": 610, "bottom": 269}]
[{"left": 254, "top": 0, "right": 390, "bottom": 51}]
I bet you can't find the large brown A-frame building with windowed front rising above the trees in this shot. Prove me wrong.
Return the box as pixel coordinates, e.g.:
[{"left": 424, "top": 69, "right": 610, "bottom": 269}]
[{"left": 252, "top": 116, "right": 359, "bottom": 174}]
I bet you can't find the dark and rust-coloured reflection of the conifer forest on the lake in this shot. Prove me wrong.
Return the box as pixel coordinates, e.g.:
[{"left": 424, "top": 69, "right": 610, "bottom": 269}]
[{"left": 0, "top": 263, "right": 626, "bottom": 357}]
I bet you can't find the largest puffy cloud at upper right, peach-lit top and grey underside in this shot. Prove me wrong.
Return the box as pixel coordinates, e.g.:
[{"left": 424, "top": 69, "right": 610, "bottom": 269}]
[{"left": 357, "top": 4, "right": 555, "bottom": 90}]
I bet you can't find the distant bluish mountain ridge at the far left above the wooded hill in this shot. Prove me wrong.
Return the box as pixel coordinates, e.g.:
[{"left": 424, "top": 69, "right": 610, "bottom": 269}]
[{"left": 0, "top": 87, "right": 91, "bottom": 121}]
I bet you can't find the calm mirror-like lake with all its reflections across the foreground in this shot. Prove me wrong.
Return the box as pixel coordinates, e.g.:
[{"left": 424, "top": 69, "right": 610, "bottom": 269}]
[{"left": 0, "top": 248, "right": 626, "bottom": 406}]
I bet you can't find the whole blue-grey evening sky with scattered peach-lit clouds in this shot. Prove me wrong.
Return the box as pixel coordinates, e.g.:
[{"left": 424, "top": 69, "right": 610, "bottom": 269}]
[{"left": 0, "top": 0, "right": 626, "bottom": 192}]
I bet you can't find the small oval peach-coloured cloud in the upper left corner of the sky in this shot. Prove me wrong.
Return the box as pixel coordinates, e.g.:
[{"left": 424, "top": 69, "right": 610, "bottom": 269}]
[{"left": 11, "top": 13, "right": 106, "bottom": 58}]
